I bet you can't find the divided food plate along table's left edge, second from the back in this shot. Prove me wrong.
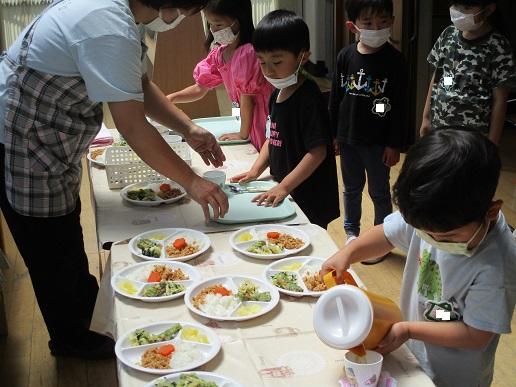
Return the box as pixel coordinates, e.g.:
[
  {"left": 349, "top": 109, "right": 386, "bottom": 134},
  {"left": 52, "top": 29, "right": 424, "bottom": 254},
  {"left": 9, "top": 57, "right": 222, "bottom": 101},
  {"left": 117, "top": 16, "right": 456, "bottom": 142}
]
[{"left": 111, "top": 261, "right": 201, "bottom": 302}]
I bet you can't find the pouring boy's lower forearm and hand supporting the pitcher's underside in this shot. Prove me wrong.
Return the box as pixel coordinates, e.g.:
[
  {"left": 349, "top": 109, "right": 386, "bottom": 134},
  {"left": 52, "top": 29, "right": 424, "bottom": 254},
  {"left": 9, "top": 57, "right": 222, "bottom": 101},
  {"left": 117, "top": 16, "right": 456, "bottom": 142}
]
[{"left": 376, "top": 320, "right": 494, "bottom": 354}]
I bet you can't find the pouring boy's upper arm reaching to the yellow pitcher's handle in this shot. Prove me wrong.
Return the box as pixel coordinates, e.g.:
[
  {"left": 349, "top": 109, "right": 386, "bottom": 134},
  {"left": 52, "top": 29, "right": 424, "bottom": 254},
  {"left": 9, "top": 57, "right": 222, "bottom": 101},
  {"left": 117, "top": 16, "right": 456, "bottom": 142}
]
[{"left": 321, "top": 224, "right": 394, "bottom": 283}]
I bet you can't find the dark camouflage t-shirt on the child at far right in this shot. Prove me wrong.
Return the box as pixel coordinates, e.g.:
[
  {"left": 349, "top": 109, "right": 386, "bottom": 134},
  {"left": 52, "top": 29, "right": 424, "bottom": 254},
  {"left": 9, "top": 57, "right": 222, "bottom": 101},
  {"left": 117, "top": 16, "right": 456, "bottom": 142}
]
[{"left": 428, "top": 26, "right": 516, "bottom": 133}]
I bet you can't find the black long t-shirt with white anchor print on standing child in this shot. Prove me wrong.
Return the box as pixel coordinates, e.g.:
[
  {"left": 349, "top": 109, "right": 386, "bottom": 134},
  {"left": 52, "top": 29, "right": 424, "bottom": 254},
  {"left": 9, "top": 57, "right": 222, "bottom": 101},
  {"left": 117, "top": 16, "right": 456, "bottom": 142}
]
[{"left": 330, "top": 43, "right": 409, "bottom": 148}]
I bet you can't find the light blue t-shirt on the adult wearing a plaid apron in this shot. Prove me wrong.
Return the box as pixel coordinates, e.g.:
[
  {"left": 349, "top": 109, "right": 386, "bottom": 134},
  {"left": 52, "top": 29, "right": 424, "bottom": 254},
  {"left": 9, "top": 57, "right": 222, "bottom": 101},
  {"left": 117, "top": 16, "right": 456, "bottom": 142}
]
[{"left": 0, "top": 0, "right": 145, "bottom": 143}]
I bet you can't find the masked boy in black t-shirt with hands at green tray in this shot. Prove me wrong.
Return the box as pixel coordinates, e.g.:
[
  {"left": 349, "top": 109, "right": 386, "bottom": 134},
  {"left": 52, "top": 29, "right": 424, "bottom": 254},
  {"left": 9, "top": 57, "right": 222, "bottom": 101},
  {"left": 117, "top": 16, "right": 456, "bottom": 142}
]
[{"left": 231, "top": 10, "right": 339, "bottom": 228}]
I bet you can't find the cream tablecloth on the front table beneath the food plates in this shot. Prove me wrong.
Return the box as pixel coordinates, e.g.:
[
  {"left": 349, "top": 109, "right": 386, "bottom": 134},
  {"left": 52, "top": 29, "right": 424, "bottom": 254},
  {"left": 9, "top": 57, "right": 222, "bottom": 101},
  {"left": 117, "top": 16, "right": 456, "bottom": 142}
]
[{"left": 92, "top": 224, "right": 433, "bottom": 387}]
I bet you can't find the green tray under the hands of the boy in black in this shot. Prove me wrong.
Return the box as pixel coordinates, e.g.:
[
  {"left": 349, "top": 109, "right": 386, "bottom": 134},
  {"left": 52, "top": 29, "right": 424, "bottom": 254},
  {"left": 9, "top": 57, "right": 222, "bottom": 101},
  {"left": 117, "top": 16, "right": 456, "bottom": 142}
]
[{"left": 210, "top": 181, "right": 296, "bottom": 224}]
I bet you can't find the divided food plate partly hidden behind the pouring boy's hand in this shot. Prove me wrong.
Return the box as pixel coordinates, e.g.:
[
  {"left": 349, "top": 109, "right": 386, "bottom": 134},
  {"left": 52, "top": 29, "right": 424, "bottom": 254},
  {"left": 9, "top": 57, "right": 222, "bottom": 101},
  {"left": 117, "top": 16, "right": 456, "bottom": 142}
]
[{"left": 264, "top": 256, "right": 361, "bottom": 297}]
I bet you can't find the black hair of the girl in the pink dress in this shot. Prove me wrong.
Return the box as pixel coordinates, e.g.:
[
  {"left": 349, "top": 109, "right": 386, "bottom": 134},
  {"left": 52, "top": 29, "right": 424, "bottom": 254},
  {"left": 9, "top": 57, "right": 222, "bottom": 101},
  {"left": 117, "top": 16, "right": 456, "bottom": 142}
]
[{"left": 204, "top": 0, "right": 254, "bottom": 50}]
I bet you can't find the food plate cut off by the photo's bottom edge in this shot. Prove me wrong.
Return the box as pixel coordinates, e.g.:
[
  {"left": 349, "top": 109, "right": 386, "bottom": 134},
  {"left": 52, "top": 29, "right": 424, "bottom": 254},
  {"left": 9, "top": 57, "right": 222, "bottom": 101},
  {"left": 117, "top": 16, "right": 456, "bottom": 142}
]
[{"left": 145, "top": 372, "right": 243, "bottom": 387}]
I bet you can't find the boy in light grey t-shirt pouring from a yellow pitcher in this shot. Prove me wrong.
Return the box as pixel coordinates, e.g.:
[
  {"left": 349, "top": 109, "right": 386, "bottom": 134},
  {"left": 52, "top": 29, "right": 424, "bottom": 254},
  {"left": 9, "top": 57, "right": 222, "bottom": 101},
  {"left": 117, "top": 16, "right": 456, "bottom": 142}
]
[{"left": 322, "top": 130, "right": 516, "bottom": 387}]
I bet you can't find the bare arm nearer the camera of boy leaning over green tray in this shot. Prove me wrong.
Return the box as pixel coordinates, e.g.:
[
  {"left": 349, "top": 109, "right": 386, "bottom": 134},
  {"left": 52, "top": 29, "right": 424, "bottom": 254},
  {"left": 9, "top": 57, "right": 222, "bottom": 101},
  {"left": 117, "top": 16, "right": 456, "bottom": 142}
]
[{"left": 253, "top": 145, "right": 326, "bottom": 207}]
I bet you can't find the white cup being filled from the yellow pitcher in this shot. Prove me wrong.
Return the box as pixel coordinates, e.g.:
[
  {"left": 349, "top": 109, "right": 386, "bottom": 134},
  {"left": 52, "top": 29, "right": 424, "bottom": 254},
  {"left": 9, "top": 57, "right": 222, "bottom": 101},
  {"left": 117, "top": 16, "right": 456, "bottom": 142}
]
[{"left": 344, "top": 350, "right": 383, "bottom": 387}]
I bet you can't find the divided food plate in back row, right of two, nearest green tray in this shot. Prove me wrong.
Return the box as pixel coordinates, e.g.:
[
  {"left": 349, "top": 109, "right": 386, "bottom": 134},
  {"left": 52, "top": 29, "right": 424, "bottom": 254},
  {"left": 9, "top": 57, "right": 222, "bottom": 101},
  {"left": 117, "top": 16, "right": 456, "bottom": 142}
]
[{"left": 229, "top": 224, "right": 310, "bottom": 259}]
